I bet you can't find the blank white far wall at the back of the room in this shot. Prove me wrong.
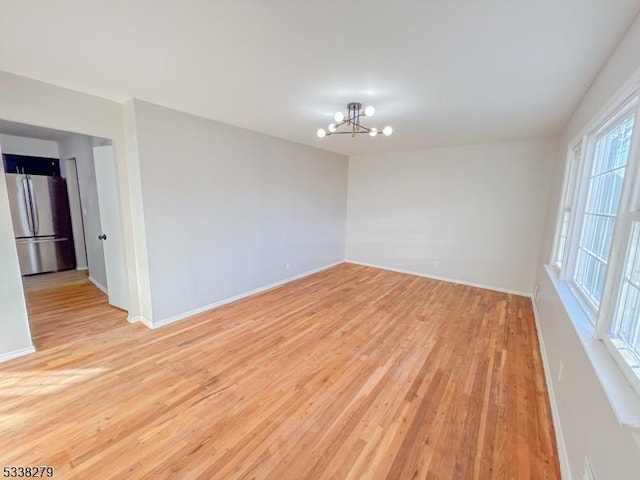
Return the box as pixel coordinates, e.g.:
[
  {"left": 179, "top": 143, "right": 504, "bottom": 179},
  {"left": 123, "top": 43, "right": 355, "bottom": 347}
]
[{"left": 347, "top": 139, "right": 555, "bottom": 293}]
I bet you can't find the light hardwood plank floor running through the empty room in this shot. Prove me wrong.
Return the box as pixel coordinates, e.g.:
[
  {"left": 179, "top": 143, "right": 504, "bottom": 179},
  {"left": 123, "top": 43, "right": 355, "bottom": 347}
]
[{"left": 0, "top": 264, "right": 560, "bottom": 480}]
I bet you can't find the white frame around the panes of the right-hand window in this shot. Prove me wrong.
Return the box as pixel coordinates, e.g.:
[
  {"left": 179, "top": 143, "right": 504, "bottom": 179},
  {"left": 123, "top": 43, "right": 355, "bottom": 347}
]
[{"left": 549, "top": 85, "right": 640, "bottom": 395}]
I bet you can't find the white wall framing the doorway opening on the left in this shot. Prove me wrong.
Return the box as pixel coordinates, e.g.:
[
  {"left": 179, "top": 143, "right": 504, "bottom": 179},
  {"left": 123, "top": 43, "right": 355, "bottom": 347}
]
[{"left": 0, "top": 72, "right": 151, "bottom": 354}]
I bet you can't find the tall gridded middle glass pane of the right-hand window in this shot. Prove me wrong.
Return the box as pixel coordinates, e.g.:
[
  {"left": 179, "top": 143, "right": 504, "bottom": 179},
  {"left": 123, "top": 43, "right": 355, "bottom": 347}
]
[{"left": 574, "top": 111, "right": 634, "bottom": 310}]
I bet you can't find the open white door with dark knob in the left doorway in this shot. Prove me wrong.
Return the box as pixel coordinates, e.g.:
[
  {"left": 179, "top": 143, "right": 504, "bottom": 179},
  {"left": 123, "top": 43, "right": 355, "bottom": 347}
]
[{"left": 93, "top": 145, "right": 129, "bottom": 310}]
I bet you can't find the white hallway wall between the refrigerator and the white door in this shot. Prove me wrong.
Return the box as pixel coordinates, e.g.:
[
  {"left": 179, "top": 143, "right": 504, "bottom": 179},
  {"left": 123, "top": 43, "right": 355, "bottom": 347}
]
[{"left": 59, "top": 134, "right": 107, "bottom": 288}]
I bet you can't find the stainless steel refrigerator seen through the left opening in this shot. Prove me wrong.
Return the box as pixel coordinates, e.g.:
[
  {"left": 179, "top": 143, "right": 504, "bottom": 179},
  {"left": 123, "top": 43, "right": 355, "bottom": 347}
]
[{"left": 5, "top": 173, "right": 76, "bottom": 275}]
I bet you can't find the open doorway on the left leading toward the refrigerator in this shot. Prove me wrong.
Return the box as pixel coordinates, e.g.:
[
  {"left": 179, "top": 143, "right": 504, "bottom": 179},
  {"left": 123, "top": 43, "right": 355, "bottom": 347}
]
[{"left": 0, "top": 120, "right": 128, "bottom": 348}]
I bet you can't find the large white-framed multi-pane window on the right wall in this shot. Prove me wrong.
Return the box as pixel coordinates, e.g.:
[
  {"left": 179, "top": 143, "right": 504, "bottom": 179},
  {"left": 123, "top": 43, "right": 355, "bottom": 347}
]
[{"left": 551, "top": 89, "right": 640, "bottom": 395}]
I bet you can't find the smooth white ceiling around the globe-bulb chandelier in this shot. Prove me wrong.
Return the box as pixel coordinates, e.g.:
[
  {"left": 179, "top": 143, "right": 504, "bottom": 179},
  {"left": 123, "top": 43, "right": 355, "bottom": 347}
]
[{"left": 0, "top": 0, "right": 640, "bottom": 154}]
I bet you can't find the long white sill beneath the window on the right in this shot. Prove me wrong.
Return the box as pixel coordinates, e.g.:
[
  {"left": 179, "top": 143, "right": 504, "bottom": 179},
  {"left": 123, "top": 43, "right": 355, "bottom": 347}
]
[{"left": 545, "top": 265, "right": 640, "bottom": 434}]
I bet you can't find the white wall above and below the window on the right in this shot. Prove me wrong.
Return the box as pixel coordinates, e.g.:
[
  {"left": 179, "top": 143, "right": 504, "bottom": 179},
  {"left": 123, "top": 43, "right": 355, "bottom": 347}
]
[{"left": 538, "top": 11, "right": 640, "bottom": 480}]
